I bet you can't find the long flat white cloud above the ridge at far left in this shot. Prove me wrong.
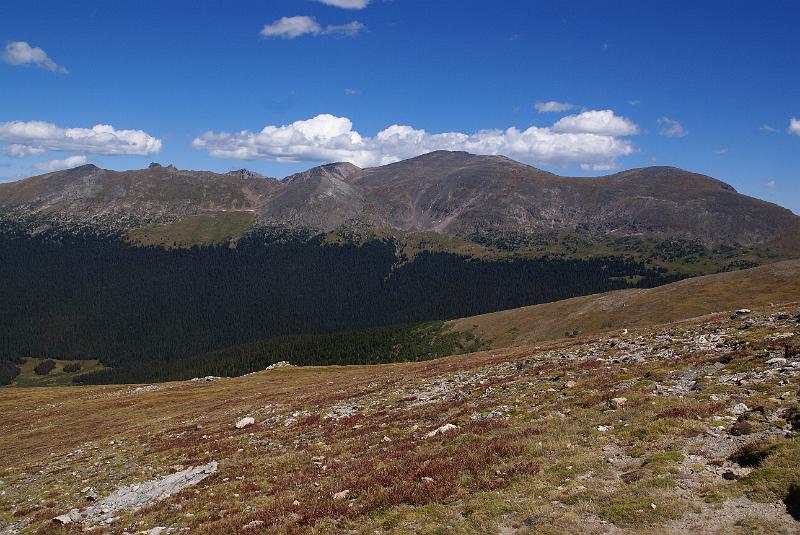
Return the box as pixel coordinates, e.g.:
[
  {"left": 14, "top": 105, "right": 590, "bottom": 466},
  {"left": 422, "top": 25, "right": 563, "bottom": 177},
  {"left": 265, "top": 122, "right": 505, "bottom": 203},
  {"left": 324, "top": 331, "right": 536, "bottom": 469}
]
[{"left": 0, "top": 121, "right": 161, "bottom": 155}]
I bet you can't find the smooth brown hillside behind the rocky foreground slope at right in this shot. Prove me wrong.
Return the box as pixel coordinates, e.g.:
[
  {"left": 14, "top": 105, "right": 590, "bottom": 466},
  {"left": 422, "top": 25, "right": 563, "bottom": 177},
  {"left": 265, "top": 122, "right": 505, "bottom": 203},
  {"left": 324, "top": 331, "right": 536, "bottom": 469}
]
[{"left": 447, "top": 260, "right": 800, "bottom": 347}]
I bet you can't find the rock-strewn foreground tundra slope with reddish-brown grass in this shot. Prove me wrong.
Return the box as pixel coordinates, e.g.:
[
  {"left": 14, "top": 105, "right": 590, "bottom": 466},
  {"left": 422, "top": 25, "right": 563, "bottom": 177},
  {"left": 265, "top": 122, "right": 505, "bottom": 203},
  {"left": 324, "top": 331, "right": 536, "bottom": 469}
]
[{"left": 0, "top": 307, "right": 800, "bottom": 535}]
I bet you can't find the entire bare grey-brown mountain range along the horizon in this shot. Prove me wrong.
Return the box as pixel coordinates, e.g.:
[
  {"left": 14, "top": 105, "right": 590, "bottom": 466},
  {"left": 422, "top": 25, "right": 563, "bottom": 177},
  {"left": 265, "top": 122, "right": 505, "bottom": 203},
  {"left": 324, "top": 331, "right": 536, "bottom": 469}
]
[{"left": 0, "top": 151, "right": 800, "bottom": 246}]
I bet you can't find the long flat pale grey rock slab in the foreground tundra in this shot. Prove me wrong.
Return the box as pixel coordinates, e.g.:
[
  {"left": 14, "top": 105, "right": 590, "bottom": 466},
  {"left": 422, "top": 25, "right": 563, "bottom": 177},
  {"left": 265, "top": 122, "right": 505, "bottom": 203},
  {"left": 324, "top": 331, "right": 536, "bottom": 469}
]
[{"left": 56, "top": 461, "right": 217, "bottom": 525}]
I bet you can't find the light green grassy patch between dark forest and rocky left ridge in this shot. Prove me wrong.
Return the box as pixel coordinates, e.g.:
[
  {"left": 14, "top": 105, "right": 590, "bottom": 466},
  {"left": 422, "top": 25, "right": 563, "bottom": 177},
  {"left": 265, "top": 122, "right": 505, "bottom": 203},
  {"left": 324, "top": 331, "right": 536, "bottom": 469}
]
[{"left": 128, "top": 211, "right": 256, "bottom": 247}]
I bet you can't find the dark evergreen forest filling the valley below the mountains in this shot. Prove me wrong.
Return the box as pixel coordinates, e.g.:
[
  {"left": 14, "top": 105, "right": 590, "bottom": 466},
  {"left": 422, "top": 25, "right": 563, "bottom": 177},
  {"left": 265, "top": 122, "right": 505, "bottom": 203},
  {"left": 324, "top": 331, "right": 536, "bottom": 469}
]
[{"left": 0, "top": 225, "right": 675, "bottom": 382}]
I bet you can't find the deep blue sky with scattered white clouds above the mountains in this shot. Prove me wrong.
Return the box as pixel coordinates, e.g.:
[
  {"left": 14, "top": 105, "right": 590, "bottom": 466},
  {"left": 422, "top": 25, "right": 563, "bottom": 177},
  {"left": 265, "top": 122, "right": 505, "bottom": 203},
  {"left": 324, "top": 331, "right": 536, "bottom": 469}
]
[{"left": 0, "top": 0, "right": 800, "bottom": 213}]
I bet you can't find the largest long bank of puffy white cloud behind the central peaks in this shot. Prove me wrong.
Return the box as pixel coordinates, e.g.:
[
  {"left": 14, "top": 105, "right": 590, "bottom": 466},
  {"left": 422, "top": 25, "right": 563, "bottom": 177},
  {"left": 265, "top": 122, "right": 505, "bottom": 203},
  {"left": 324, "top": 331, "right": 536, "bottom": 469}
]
[{"left": 192, "top": 114, "right": 638, "bottom": 168}]
